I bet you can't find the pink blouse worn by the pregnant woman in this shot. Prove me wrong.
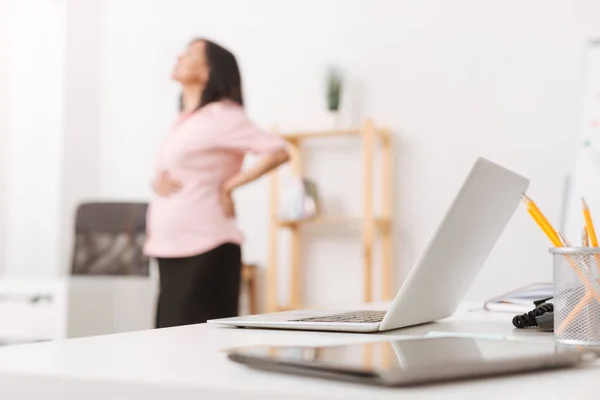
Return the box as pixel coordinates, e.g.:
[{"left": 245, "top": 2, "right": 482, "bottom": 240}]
[{"left": 145, "top": 102, "right": 284, "bottom": 258}]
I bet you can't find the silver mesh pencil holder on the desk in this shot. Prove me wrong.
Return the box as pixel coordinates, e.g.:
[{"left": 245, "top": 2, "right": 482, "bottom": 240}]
[{"left": 550, "top": 247, "right": 600, "bottom": 346}]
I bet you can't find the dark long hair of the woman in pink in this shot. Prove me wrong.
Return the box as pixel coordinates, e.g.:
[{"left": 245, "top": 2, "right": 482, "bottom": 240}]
[{"left": 179, "top": 38, "right": 244, "bottom": 110}]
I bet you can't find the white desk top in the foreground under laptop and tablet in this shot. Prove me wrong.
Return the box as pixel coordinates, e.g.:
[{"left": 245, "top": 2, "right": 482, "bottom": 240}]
[{"left": 0, "top": 304, "right": 600, "bottom": 400}]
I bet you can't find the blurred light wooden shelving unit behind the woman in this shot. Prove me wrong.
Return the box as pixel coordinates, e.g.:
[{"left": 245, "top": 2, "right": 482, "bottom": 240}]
[{"left": 268, "top": 120, "right": 393, "bottom": 311}]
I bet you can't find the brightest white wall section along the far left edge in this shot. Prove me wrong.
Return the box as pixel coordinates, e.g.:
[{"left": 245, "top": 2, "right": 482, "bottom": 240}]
[{"left": 5, "top": 0, "right": 65, "bottom": 275}]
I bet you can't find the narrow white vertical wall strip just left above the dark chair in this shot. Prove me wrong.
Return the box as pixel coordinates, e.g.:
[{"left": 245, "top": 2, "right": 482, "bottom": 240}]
[{"left": 60, "top": 0, "right": 103, "bottom": 272}]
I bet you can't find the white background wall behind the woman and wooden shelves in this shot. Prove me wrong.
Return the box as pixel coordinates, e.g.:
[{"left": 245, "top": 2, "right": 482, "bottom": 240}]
[{"left": 5, "top": 0, "right": 600, "bottom": 305}]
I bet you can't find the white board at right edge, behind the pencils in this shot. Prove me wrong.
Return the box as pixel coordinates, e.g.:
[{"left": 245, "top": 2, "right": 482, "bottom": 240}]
[{"left": 561, "top": 40, "right": 600, "bottom": 245}]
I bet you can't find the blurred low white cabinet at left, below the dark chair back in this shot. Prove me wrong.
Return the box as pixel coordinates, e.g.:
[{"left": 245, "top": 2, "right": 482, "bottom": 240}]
[{"left": 0, "top": 276, "right": 157, "bottom": 342}]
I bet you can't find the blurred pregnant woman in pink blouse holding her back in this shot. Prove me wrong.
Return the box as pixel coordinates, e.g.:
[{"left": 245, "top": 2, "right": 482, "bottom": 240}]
[{"left": 145, "top": 39, "right": 289, "bottom": 327}]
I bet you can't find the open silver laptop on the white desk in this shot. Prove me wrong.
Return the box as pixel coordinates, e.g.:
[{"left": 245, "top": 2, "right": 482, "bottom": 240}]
[{"left": 208, "top": 158, "right": 529, "bottom": 332}]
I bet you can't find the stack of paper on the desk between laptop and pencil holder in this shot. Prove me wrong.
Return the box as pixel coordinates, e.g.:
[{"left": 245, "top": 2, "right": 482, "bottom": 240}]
[{"left": 484, "top": 283, "right": 554, "bottom": 313}]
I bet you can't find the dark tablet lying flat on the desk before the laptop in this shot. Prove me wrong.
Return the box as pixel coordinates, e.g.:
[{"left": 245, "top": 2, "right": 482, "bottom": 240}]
[{"left": 229, "top": 337, "right": 596, "bottom": 386}]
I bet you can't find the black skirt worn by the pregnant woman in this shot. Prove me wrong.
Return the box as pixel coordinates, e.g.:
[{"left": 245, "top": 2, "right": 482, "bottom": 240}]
[{"left": 156, "top": 243, "right": 242, "bottom": 328}]
